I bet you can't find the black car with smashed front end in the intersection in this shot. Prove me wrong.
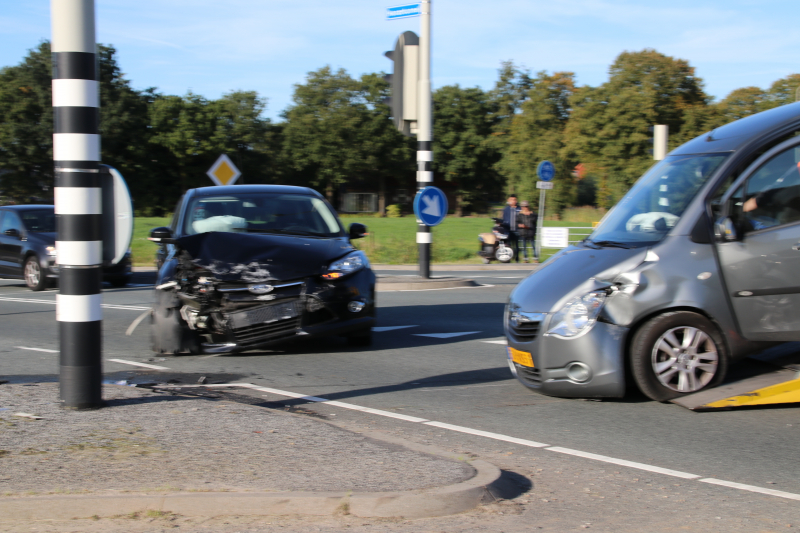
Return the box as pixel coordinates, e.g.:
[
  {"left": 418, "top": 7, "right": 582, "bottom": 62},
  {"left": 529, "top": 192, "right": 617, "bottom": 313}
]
[{"left": 150, "top": 185, "right": 375, "bottom": 354}]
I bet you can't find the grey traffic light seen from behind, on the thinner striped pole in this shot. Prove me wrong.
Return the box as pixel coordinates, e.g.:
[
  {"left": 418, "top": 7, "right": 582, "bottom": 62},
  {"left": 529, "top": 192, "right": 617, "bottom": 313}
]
[{"left": 385, "top": 31, "right": 419, "bottom": 136}]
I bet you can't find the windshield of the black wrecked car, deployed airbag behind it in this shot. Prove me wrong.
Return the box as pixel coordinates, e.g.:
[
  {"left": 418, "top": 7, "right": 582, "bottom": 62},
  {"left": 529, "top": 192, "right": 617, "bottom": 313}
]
[{"left": 184, "top": 193, "right": 343, "bottom": 237}]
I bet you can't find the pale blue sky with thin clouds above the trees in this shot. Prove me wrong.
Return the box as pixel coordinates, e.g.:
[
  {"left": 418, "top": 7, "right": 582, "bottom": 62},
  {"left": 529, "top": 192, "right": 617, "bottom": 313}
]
[{"left": 0, "top": 0, "right": 800, "bottom": 119}]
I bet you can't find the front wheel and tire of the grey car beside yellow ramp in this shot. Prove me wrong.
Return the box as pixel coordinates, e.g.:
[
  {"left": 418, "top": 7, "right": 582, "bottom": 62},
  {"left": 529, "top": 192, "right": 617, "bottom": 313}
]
[{"left": 630, "top": 311, "right": 728, "bottom": 402}]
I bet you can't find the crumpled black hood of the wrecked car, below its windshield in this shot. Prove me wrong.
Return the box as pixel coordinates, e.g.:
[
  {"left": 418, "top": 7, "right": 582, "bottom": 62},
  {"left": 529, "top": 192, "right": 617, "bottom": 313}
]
[{"left": 177, "top": 232, "right": 355, "bottom": 283}]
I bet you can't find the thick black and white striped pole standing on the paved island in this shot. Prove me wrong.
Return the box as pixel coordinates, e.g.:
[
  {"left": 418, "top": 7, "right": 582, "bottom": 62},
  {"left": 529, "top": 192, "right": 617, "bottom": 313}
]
[{"left": 50, "top": 0, "right": 103, "bottom": 409}]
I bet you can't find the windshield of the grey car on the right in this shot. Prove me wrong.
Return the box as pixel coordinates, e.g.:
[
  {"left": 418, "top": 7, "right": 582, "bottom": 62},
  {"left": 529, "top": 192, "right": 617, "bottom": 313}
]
[{"left": 585, "top": 154, "right": 728, "bottom": 247}]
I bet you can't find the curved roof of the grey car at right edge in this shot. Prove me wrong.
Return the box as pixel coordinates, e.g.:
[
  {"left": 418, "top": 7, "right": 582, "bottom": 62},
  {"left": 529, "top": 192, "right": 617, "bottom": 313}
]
[{"left": 670, "top": 102, "right": 800, "bottom": 155}]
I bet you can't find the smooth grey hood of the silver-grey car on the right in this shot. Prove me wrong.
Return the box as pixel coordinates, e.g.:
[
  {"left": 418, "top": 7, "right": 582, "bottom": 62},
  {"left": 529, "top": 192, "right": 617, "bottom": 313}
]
[{"left": 511, "top": 246, "right": 648, "bottom": 313}]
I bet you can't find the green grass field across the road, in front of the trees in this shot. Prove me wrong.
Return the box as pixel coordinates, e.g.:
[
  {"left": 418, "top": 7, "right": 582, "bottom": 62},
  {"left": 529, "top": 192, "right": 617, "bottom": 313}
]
[{"left": 131, "top": 216, "right": 592, "bottom": 266}]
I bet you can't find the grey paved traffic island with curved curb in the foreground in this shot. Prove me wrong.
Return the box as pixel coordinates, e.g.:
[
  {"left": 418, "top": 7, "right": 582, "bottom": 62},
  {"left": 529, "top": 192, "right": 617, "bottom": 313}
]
[{"left": 0, "top": 381, "right": 503, "bottom": 524}]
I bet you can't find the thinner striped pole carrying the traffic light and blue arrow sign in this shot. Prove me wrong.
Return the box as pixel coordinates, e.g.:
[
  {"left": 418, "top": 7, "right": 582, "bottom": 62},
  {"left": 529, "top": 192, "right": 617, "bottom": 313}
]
[{"left": 417, "top": 0, "right": 433, "bottom": 278}]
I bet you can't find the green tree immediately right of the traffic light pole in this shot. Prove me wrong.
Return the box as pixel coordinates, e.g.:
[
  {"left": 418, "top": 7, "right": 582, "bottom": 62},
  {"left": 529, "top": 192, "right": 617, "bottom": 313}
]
[{"left": 433, "top": 85, "right": 502, "bottom": 216}]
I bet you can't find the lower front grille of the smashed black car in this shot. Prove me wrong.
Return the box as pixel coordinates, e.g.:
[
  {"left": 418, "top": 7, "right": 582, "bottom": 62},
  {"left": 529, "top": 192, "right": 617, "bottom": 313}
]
[{"left": 227, "top": 300, "right": 303, "bottom": 345}]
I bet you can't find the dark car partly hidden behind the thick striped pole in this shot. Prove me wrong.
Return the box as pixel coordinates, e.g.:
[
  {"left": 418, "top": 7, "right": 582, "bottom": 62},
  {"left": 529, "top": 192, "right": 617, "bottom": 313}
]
[{"left": 0, "top": 205, "right": 131, "bottom": 291}]
